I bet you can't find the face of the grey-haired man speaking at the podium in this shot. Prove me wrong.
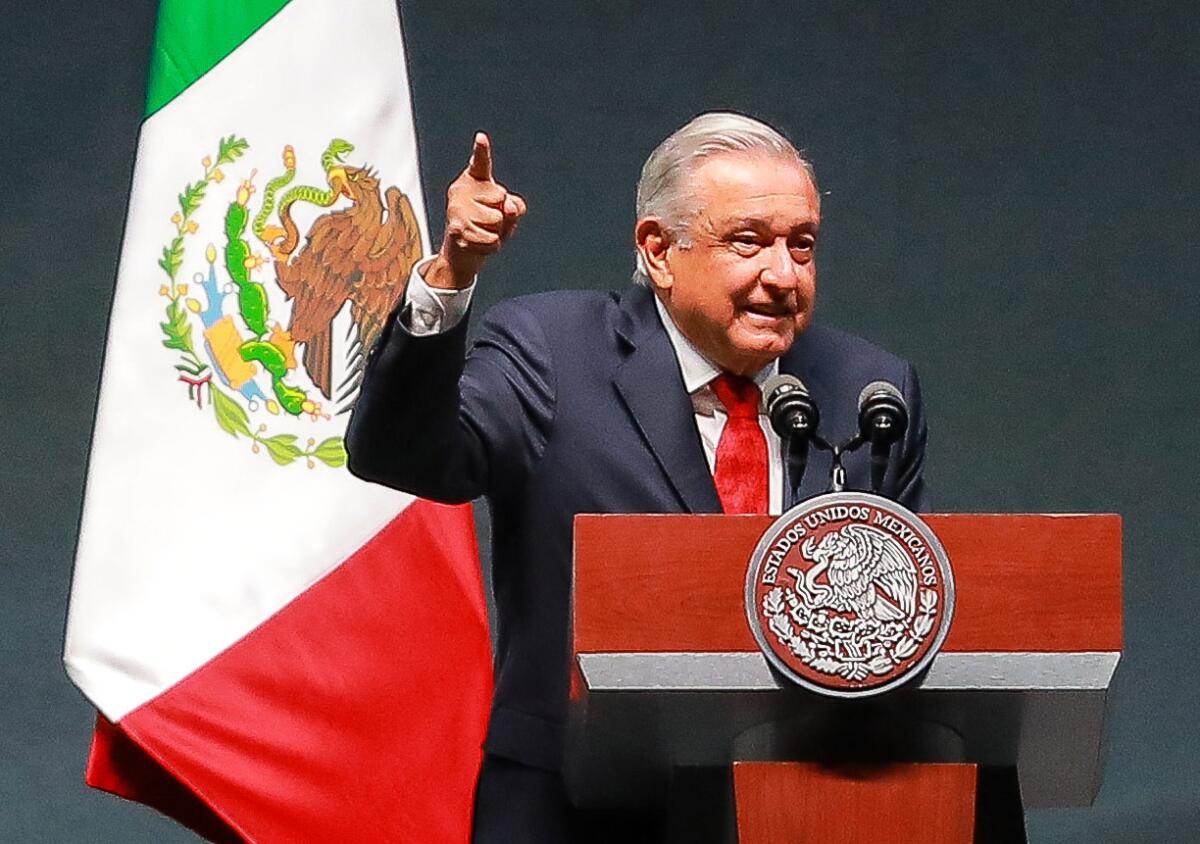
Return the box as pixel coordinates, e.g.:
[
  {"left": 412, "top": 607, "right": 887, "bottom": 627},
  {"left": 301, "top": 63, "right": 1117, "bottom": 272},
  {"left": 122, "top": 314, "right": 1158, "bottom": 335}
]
[{"left": 650, "top": 154, "right": 821, "bottom": 375}]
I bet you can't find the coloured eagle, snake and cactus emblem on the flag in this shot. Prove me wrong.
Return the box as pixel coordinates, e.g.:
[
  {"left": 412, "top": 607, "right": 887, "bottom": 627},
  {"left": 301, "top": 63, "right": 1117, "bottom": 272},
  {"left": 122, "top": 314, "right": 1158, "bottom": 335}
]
[{"left": 151, "top": 136, "right": 422, "bottom": 468}]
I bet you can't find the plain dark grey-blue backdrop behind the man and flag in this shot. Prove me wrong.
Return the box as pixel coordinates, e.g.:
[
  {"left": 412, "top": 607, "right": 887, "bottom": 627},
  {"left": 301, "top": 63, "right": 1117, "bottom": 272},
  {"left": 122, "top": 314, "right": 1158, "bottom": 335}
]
[{"left": 0, "top": 0, "right": 1200, "bottom": 842}]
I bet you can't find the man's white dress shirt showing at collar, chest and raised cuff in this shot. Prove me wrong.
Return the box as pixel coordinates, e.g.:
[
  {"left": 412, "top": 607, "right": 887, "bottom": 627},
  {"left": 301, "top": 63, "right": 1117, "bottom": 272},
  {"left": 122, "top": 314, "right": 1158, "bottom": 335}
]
[{"left": 401, "top": 258, "right": 784, "bottom": 515}]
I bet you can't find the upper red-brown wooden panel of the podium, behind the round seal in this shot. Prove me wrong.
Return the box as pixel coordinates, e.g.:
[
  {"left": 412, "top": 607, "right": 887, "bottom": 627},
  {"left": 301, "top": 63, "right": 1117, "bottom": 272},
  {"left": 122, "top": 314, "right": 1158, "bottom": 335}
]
[{"left": 574, "top": 514, "right": 1122, "bottom": 653}]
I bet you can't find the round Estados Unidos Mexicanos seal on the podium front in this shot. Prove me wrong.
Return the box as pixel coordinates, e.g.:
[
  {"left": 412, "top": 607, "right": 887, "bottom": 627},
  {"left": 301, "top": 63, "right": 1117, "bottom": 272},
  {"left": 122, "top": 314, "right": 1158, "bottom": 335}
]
[{"left": 745, "top": 492, "right": 954, "bottom": 698}]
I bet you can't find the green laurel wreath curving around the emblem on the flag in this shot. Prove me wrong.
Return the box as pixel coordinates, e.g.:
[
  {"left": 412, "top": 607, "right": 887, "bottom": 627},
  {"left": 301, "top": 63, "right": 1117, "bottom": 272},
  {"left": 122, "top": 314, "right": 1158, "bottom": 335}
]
[{"left": 158, "top": 134, "right": 346, "bottom": 468}]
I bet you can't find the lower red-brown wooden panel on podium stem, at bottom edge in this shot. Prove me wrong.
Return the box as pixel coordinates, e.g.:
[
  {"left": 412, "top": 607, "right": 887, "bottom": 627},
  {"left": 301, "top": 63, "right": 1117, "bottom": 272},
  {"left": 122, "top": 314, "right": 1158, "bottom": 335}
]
[{"left": 733, "top": 762, "right": 977, "bottom": 844}]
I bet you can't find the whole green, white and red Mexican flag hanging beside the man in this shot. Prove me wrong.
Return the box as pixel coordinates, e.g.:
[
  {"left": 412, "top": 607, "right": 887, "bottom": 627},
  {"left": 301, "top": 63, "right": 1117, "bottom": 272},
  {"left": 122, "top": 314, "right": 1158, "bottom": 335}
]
[{"left": 65, "top": 0, "right": 492, "bottom": 842}]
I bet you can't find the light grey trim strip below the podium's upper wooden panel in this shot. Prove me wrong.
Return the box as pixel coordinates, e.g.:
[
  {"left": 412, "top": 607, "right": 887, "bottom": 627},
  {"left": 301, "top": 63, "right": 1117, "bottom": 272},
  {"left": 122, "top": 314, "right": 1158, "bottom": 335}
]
[{"left": 578, "top": 651, "right": 1121, "bottom": 692}]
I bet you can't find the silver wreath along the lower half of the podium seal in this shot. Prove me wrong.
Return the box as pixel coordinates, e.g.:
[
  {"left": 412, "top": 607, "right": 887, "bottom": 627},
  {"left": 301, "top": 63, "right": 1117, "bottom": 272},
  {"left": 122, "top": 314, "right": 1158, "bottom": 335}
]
[{"left": 762, "top": 586, "right": 937, "bottom": 682}]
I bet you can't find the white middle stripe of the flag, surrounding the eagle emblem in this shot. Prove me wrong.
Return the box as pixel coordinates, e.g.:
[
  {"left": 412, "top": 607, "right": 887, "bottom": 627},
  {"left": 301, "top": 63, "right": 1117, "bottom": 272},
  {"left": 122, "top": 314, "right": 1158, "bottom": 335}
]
[{"left": 66, "top": 0, "right": 428, "bottom": 720}]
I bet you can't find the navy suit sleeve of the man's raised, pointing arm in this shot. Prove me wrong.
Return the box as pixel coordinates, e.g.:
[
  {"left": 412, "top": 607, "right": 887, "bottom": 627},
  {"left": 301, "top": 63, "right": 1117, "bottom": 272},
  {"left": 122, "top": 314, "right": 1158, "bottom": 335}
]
[{"left": 346, "top": 303, "right": 554, "bottom": 503}]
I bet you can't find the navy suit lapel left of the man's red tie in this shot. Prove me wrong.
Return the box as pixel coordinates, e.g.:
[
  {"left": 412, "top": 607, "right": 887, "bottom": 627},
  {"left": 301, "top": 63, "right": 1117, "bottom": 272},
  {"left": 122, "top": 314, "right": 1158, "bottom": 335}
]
[{"left": 614, "top": 287, "right": 721, "bottom": 513}]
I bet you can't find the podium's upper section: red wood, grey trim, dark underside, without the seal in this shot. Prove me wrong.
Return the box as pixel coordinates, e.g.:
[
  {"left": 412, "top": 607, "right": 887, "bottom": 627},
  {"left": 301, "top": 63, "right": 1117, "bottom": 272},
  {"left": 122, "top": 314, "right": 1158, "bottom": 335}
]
[{"left": 566, "top": 514, "right": 1122, "bottom": 807}]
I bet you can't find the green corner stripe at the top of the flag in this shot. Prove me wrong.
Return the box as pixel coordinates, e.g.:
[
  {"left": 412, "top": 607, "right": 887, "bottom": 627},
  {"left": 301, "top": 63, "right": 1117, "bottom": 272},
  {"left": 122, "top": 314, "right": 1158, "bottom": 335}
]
[{"left": 145, "top": 0, "right": 288, "bottom": 118}]
